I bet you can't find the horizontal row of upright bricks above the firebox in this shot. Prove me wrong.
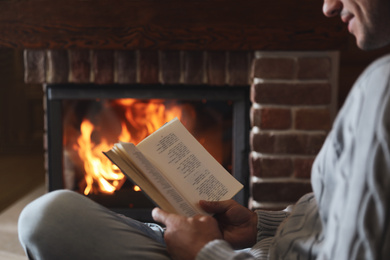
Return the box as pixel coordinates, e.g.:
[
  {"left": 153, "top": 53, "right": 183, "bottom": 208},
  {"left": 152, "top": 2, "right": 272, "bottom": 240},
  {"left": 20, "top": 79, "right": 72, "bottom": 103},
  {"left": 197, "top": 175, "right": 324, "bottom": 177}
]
[{"left": 24, "top": 50, "right": 253, "bottom": 86}]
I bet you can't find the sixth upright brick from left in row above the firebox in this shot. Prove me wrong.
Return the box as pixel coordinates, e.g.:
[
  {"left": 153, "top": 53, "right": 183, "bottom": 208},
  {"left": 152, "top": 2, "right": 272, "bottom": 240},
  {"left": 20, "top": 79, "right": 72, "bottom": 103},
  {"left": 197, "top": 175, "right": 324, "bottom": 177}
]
[{"left": 139, "top": 50, "right": 159, "bottom": 84}]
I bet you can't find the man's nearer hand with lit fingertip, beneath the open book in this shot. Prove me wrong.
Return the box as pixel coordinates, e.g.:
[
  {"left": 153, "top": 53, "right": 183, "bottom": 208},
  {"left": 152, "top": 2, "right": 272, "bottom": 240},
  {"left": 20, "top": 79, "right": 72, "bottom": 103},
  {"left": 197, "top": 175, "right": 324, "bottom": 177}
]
[{"left": 152, "top": 208, "right": 222, "bottom": 260}]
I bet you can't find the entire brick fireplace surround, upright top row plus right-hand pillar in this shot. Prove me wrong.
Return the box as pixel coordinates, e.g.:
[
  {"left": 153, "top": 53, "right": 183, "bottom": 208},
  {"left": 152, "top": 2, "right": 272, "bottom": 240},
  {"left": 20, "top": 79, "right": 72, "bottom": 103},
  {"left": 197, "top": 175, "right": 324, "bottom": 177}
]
[{"left": 24, "top": 50, "right": 338, "bottom": 209}]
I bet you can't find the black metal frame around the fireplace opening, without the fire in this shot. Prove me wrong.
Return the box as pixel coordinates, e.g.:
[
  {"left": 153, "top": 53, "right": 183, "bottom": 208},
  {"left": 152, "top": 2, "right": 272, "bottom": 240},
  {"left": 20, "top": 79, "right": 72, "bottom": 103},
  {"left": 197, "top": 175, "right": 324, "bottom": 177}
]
[{"left": 44, "top": 83, "right": 250, "bottom": 221}]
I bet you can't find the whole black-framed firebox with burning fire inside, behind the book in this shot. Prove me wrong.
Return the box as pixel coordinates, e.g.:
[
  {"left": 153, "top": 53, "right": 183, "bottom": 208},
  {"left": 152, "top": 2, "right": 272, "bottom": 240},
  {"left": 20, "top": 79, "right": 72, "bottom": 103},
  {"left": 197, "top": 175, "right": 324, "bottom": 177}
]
[{"left": 45, "top": 84, "right": 249, "bottom": 221}]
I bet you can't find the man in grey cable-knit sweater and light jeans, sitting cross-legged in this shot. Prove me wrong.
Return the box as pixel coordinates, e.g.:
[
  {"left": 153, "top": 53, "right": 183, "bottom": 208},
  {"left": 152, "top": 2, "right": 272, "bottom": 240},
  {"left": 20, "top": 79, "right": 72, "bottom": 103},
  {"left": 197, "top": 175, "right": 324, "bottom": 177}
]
[{"left": 19, "top": 0, "right": 390, "bottom": 260}]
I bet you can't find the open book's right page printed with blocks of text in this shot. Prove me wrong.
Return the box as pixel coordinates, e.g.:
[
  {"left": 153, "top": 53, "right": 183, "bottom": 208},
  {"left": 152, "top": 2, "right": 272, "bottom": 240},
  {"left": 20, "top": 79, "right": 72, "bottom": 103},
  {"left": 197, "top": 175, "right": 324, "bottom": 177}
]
[{"left": 137, "top": 118, "right": 243, "bottom": 209}]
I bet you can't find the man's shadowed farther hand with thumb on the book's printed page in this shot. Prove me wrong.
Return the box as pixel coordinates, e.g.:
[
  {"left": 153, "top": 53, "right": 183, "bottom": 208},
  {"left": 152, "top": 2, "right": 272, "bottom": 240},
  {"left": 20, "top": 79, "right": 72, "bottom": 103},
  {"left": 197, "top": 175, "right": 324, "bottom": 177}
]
[{"left": 199, "top": 200, "right": 257, "bottom": 249}]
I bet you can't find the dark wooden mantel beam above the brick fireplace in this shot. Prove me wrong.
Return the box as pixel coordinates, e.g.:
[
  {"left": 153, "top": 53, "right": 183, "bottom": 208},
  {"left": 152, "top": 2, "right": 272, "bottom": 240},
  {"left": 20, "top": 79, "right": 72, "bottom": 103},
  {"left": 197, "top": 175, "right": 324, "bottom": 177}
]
[{"left": 0, "top": 0, "right": 347, "bottom": 50}]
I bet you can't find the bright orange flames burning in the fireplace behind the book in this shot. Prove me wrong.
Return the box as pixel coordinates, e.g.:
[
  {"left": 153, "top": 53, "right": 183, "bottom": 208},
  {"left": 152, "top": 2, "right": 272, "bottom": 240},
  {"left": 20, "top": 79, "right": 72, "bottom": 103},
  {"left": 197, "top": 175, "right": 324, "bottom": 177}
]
[{"left": 74, "top": 99, "right": 190, "bottom": 195}]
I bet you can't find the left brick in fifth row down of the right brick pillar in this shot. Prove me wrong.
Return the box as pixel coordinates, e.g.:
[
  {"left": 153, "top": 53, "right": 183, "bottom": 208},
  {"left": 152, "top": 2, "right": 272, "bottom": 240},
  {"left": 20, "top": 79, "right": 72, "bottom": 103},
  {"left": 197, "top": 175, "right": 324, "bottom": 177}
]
[{"left": 250, "top": 155, "right": 293, "bottom": 178}]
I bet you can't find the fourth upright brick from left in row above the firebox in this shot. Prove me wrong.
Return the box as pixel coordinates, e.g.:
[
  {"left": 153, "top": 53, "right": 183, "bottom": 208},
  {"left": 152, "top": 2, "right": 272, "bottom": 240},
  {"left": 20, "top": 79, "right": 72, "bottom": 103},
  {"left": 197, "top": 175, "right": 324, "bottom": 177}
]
[{"left": 92, "top": 50, "right": 114, "bottom": 84}]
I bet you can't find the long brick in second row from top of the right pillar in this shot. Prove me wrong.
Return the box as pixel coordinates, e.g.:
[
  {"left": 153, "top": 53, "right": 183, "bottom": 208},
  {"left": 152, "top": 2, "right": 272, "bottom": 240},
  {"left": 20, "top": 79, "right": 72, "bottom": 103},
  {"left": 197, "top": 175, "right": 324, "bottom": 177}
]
[{"left": 251, "top": 83, "right": 331, "bottom": 105}]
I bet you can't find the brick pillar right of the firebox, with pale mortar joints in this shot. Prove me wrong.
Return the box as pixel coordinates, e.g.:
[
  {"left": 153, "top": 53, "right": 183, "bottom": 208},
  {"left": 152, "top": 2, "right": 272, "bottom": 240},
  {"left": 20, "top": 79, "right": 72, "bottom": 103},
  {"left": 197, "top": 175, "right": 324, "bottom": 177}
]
[{"left": 250, "top": 52, "right": 338, "bottom": 209}]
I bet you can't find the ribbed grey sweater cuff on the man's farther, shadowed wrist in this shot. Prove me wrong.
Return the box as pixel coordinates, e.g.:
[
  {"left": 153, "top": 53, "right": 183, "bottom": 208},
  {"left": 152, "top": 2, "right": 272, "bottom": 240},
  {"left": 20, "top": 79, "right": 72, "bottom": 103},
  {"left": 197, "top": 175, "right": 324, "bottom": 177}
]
[{"left": 256, "top": 210, "right": 290, "bottom": 242}]
